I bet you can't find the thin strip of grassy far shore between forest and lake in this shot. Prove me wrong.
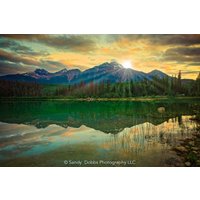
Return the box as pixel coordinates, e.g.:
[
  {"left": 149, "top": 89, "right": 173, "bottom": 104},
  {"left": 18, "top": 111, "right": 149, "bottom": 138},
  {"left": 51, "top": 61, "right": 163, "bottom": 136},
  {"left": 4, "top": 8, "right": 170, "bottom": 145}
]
[{"left": 0, "top": 96, "right": 200, "bottom": 101}]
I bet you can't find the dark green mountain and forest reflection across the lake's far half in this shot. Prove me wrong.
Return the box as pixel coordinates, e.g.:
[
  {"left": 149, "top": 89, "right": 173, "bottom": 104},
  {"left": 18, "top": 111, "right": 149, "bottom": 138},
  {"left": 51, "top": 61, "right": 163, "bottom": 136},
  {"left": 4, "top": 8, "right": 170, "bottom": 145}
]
[{"left": 0, "top": 101, "right": 197, "bottom": 133}]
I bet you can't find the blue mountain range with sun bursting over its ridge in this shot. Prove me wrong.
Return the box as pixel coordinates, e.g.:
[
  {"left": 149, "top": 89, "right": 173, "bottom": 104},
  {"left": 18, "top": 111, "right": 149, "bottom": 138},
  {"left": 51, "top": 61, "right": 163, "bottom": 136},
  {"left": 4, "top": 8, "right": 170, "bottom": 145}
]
[{"left": 0, "top": 62, "right": 172, "bottom": 84}]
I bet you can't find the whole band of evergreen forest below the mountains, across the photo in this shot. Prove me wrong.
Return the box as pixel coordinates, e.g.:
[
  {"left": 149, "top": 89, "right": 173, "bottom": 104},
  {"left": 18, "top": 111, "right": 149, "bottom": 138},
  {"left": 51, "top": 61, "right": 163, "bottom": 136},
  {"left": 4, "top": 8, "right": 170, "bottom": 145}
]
[{"left": 0, "top": 72, "right": 200, "bottom": 98}]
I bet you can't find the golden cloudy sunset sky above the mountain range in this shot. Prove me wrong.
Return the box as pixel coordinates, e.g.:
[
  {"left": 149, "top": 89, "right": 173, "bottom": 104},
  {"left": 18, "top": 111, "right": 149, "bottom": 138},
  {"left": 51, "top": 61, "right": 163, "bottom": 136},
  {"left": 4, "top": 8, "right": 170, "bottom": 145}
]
[{"left": 0, "top": 34, "right": 200, "bottom": 79}]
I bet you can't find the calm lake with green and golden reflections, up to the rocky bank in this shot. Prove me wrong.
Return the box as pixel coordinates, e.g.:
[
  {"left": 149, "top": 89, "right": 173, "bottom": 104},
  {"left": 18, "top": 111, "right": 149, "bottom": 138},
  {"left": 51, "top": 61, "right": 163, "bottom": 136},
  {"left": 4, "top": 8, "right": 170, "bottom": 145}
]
[{"left": 0, "top": 100, "right": 199, "bottom": 167}]
